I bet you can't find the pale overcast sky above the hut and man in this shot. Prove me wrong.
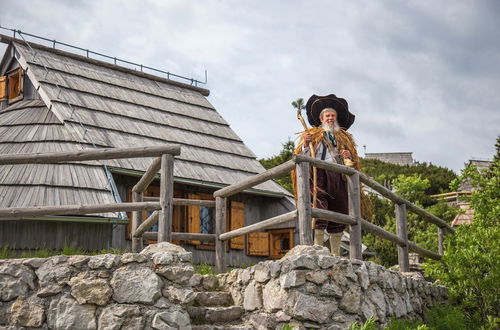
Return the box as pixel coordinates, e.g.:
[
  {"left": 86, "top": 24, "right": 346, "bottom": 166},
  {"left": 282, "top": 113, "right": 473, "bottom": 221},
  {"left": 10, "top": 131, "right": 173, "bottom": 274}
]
[{"left": 0, "top": 0, "right": 500, "bottom": 172}]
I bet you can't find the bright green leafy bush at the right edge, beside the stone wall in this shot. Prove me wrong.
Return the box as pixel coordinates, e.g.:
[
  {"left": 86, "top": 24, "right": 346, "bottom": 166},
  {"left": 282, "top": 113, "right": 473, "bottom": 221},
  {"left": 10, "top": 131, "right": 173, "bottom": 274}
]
[{"left": 424, "top": 148, "right": 500, "bottom": 327}]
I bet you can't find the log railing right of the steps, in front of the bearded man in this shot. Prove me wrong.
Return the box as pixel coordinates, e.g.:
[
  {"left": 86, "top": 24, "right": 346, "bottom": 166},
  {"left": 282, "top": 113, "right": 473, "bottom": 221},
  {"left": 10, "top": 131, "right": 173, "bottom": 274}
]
[{"left": 214, "top": 155, "right": 454, "bottom": 272}]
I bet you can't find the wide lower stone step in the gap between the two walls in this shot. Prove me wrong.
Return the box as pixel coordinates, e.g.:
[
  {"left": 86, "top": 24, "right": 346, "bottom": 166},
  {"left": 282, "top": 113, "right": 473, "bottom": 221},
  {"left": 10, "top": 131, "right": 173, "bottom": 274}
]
[{"left": 187, "top": 306, "right": 244, "bottom": 324}]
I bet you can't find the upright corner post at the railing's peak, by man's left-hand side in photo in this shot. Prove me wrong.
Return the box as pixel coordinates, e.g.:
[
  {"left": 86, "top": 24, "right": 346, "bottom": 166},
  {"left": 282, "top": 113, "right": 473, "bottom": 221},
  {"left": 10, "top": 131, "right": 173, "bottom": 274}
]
[{"left": 297, "top": 162, "right": 313, "bottom": 245}]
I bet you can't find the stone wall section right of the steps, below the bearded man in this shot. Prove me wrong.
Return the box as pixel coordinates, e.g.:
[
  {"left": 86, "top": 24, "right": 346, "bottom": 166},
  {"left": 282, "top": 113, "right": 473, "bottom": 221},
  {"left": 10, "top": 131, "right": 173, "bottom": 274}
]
[{"left": 221, "top": 246, "right": 448, "bottom": 329}]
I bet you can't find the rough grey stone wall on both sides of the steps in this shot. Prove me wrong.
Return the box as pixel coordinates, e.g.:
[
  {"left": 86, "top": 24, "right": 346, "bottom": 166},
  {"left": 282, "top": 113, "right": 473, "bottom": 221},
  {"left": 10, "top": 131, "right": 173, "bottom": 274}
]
[{"left": 0, "top": 243, "right": 447, "bottom": 329}]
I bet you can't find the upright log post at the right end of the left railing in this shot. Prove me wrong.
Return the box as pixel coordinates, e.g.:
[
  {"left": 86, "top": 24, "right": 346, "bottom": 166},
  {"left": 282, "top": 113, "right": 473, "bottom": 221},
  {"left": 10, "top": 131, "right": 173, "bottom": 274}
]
[{"left": 158, "top": 154, "right": 174, "bottom": 242}]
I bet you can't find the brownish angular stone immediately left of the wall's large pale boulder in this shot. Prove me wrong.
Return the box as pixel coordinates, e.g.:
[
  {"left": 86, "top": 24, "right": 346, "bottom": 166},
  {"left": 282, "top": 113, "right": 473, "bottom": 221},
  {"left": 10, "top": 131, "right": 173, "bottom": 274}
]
[{"left": 68, "top": 273, "right": 113, "bottom": 306}]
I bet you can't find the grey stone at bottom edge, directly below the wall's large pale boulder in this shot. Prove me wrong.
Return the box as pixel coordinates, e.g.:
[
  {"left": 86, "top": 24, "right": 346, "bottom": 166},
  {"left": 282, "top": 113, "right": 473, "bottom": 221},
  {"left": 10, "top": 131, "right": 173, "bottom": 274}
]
[{"left": 99, "top": 305, "right": 145, "bottom": 330}]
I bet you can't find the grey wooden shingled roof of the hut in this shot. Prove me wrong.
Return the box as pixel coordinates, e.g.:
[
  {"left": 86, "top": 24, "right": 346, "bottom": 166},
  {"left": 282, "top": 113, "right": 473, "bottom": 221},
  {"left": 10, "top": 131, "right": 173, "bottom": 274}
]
[{"left": 0, "top": 36, "right": 289, "bottom": 217}]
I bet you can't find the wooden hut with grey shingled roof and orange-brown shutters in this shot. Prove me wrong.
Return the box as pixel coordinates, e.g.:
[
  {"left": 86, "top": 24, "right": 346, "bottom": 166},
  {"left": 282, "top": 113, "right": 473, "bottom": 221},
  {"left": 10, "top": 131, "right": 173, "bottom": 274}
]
[{"left": 0, "top": 35, "right": 297, "bottom": 265}]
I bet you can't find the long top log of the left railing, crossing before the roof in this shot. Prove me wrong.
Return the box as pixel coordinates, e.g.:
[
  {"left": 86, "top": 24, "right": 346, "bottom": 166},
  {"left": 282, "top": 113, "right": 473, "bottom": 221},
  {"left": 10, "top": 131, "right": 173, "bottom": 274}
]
[{"left": 0, "top": 146, "right": 181, "bottom": 165}]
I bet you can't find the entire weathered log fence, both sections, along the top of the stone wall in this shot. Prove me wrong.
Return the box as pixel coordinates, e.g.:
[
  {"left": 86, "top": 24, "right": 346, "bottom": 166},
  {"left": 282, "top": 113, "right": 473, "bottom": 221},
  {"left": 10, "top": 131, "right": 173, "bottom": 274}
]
[{"left": 0, "top": 146, "right": 454, "bottom": 272}]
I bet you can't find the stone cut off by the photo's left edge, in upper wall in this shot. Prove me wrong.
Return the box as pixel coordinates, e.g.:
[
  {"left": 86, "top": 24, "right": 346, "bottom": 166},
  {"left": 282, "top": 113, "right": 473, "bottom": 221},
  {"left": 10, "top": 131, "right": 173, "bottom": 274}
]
[{"left": 0, "top": 262, "right": 35, "bottom": 301}]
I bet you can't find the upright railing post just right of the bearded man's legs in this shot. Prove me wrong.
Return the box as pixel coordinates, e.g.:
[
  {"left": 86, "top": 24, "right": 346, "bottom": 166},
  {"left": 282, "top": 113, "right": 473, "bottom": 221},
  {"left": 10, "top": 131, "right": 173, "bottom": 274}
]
[{"left": 347, "top": 173, "right": 363, "bottom": 260}]
